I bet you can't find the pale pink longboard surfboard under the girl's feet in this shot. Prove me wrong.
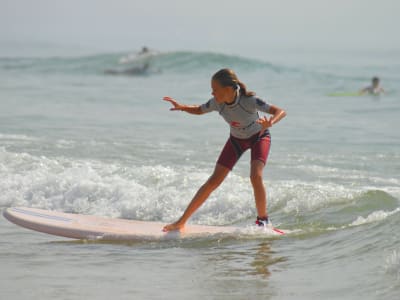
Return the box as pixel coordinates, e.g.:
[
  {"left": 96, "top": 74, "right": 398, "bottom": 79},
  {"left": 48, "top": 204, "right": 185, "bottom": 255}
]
[{"left": 3, "top": 207, "right": 285, "bottom": 241}]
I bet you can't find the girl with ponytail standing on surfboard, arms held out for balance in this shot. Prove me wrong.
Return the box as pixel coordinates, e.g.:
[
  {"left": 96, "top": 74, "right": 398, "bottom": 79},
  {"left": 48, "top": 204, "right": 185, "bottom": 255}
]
[{"left": 163, "top": 69, "right": 286, "bottom": 231}]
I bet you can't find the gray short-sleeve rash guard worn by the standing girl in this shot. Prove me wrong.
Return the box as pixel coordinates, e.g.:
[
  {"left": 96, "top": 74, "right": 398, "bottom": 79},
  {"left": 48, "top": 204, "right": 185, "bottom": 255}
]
[{"left": 201, "top": 96, "right": 270, "bottom": 139}]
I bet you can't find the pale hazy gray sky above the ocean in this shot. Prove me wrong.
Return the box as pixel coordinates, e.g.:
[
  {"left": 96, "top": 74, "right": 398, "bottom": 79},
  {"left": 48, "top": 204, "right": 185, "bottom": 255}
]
[{"left": 0, "top": 0, "right": 400, "bottom": 53}]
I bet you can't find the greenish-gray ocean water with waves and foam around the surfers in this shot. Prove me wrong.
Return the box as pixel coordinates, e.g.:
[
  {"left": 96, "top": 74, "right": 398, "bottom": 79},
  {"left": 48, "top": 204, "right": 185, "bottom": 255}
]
[{"left": 0, "top": 45, "right": 400, "bottom": 299}]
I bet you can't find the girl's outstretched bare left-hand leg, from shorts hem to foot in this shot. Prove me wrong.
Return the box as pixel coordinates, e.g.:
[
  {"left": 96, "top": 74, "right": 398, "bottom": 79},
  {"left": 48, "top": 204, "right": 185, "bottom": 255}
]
[{"left": 163, "top": 163, "right": 230, "bottom": 231}]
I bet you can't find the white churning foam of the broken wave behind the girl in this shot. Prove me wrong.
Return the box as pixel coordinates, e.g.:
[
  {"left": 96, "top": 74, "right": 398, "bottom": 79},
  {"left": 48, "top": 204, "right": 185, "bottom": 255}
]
[{"left": 0, "top": 145, "right": 397, "bottom": 230}]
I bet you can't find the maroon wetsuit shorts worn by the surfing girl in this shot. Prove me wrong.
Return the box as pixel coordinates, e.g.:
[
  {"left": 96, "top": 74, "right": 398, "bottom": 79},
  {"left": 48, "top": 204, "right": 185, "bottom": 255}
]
[{"left": 217, "top": 130, "right": 271, "bottom": 170}]
